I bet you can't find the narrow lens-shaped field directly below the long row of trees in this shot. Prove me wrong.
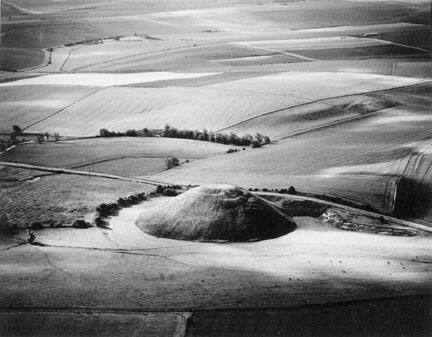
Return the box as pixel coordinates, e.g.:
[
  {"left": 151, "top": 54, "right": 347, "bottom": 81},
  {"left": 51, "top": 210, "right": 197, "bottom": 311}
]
[{"left": 0, "top": 137, "right": 233, "bottom": 169}]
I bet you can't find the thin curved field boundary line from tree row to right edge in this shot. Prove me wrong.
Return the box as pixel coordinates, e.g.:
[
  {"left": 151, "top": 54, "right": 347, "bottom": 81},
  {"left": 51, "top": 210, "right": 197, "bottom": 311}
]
[{"left": 214, "top": 80, "right": 432, "bottom": 135}]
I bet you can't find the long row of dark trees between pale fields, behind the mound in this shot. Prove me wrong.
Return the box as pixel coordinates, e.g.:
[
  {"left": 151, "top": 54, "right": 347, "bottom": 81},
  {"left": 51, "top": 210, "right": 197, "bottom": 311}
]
[{"left": 99, "top": 124, "right": 271, "bottom": 147}]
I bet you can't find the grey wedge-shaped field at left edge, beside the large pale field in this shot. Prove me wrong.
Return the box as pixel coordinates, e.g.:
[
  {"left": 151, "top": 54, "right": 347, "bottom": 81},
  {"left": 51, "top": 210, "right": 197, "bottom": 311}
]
[{"left": 0, "top": 85, "right": 96, "bottom": 132}]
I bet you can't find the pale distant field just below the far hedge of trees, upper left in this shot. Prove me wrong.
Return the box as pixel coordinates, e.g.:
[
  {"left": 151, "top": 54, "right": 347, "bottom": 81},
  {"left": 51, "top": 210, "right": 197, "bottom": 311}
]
[{"left": 58, "top": 37, "right": 252, "bottom": 72}]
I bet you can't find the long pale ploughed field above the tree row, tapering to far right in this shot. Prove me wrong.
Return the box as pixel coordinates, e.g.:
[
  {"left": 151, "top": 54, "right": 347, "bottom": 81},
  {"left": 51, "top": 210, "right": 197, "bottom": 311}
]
[{"left": 19, "top": 72, "right": 421, "bottom": 136}]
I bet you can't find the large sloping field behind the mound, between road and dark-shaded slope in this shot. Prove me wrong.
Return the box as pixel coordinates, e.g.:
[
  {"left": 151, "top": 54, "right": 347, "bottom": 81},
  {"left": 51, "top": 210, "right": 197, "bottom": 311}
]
[{"left": 158, "top": 85, "right": 432, "bottom": 213}]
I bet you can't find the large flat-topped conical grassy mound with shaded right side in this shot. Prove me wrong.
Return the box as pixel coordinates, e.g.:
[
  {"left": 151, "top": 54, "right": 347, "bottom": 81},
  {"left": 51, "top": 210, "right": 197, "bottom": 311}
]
[{"left": 136, "top": 185, "right": 296, "bottom": 242}]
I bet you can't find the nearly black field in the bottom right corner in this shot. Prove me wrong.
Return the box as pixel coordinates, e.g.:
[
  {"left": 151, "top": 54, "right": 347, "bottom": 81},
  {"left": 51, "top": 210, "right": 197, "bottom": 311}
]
[{"left": 187, "top": 294, "right": 432, "bottom": 337}]
